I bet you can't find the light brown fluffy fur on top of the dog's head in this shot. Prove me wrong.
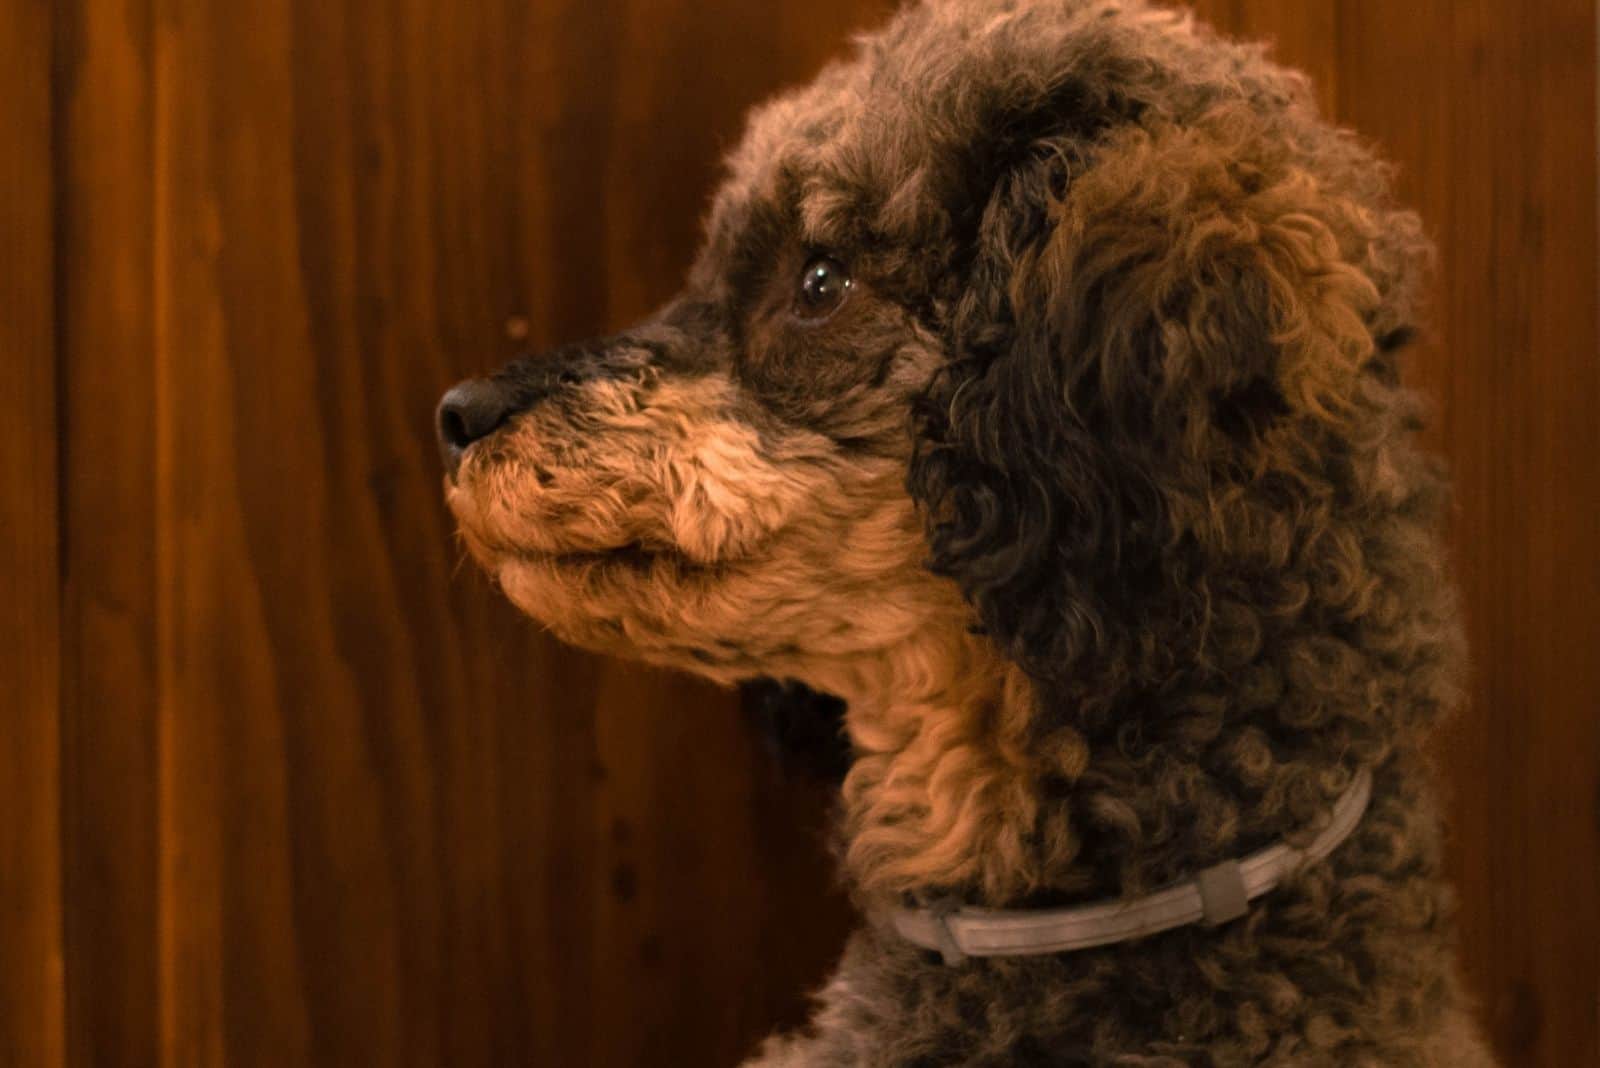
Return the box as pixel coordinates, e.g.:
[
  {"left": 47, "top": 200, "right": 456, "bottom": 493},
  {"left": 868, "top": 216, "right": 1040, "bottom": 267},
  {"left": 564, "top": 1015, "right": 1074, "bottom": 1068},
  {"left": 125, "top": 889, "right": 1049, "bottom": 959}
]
[{"left": 710, "top": 0, "right": 1304, "bottom": 259}]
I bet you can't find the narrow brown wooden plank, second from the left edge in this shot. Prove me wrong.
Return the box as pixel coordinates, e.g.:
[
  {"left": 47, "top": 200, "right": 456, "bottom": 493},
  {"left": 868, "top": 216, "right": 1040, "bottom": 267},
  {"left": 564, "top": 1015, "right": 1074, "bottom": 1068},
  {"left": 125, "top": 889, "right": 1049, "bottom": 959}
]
[{"left": 58, "top": 0, "right": 158, "bottom": 1065}]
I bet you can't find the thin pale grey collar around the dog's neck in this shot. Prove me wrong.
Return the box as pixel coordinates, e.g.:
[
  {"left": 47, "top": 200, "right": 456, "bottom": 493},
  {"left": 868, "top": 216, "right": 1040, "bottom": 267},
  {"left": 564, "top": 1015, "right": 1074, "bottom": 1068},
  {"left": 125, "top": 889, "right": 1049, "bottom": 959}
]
[{"left": 888, "top": 767, "right": 1373, "bottom": 964}]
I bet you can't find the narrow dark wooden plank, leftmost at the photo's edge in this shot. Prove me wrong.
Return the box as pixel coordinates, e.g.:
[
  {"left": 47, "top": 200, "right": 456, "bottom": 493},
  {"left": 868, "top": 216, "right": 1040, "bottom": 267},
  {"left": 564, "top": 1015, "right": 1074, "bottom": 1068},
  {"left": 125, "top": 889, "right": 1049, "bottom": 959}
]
[{"left": 0, "top": 0, "right": 66, "bottom": 1068}]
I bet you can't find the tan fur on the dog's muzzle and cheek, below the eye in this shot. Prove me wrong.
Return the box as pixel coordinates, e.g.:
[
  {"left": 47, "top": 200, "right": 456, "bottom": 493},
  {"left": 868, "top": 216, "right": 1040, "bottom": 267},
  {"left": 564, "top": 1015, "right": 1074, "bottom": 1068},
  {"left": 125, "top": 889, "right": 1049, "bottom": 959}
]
[{"left": 446, "top": 364, "right": 958, "bottom": 683}]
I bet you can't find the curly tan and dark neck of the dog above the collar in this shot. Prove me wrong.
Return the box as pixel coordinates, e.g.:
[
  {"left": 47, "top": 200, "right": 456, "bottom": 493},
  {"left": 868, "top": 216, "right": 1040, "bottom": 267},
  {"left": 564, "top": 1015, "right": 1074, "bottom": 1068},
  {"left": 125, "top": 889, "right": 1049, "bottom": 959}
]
[{"left": 818, "top": 628, "right": 1376, "bottom": 908}]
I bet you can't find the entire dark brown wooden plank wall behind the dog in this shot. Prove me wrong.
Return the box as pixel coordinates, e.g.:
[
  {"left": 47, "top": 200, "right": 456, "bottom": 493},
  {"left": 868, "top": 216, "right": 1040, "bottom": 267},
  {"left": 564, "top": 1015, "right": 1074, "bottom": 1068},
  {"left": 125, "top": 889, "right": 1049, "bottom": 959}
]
[{"left": 0, "top": 0, "right": 1600, "bottom": 1068}]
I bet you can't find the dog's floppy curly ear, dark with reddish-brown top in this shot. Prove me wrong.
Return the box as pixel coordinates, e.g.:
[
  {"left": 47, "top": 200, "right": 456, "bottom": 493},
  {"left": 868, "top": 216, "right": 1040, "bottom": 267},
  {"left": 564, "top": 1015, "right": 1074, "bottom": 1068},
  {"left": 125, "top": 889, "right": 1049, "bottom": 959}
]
[{"left": 909, "top": 106, "right": 1426, "bottom": 705}]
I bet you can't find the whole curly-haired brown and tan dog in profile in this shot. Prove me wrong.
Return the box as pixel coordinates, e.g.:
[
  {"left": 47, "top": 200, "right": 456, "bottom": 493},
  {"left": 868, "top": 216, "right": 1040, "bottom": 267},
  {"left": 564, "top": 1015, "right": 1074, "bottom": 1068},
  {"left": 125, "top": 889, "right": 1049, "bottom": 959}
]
[{"left": 440, "top": 0, "right": 1490, "bottom": 1068}]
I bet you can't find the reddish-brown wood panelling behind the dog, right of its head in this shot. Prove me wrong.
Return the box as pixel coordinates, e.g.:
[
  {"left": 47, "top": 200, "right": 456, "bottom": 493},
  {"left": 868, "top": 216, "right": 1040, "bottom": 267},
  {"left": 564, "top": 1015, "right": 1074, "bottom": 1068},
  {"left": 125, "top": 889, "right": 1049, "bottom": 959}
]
[{"left": 1339, "top": 0, "right": 1600, "bottom": 1066}]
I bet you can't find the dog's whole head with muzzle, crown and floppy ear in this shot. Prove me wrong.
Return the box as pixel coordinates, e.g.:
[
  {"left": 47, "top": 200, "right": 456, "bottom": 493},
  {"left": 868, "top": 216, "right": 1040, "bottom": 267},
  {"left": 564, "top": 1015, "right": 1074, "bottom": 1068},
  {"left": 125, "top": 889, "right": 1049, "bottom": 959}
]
[{"left": 440, "top": 0, "right": 1448, "bottom": 901}]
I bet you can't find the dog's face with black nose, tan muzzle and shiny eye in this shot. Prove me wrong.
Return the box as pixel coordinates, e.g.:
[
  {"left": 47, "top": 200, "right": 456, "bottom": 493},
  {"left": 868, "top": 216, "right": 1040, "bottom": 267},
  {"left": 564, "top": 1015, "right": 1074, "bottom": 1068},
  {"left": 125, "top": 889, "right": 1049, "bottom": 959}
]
[{"left": 440, "top": 217, "right": 960, "bottom": 681}]
